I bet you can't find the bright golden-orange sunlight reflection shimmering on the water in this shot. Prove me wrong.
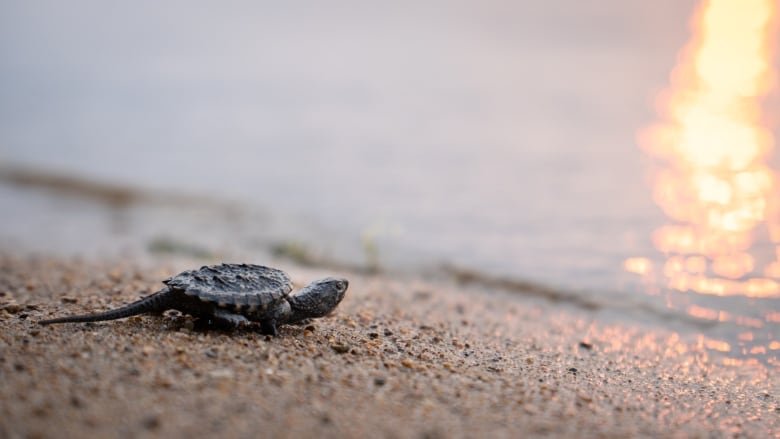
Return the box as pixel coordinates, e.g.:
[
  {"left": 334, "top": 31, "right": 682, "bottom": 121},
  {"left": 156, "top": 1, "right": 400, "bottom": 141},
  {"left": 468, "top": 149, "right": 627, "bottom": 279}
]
[{"left": 623, "top": 0, "right": 780, "bottom": 364}]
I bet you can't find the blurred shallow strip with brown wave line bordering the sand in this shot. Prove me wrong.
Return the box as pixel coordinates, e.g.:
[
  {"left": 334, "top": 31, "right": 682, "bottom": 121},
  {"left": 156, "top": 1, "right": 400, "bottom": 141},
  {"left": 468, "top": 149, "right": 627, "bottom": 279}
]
[{"left": 0, "top": 174, "right": 780, "bottom": 367}]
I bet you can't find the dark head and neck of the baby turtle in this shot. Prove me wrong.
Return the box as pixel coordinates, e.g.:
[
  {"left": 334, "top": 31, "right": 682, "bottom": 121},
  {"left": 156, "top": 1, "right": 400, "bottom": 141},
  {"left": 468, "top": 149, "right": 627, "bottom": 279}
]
[{"left": 287, "top": 277, "right": 349, "bottom": 323}]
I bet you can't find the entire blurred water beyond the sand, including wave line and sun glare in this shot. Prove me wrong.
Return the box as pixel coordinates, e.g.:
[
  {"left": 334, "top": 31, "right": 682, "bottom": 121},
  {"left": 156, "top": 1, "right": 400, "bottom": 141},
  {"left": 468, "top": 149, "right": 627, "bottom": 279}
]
[{"left": 0, "top": 0, "right": 780, "bottom": 364}]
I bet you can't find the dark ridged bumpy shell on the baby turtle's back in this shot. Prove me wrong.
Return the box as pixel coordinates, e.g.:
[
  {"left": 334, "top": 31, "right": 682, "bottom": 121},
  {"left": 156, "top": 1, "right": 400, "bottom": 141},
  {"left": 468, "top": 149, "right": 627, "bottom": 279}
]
[{"left": 163, "top": 264, "right": 292, "bottom": 312}]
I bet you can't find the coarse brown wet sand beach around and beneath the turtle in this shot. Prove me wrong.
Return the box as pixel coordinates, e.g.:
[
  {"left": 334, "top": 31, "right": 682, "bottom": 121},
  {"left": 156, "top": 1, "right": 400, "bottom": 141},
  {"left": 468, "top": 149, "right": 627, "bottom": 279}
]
[{"left": 0, "top": 256, "right": 780, "bottom": 438}]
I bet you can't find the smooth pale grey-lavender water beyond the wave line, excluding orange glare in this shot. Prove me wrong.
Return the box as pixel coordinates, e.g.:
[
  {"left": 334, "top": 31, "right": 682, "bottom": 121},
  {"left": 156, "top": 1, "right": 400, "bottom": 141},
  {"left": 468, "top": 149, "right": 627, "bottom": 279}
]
[{"left": 0, "top": 0, "right": 780, "bottom": 364}]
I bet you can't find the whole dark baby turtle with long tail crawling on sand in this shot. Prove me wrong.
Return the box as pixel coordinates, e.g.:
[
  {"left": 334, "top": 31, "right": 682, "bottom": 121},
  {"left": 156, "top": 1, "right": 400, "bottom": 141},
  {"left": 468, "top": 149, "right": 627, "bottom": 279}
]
[{"left": 40, "top": 264, "right": 349, "bottom": 335}]
